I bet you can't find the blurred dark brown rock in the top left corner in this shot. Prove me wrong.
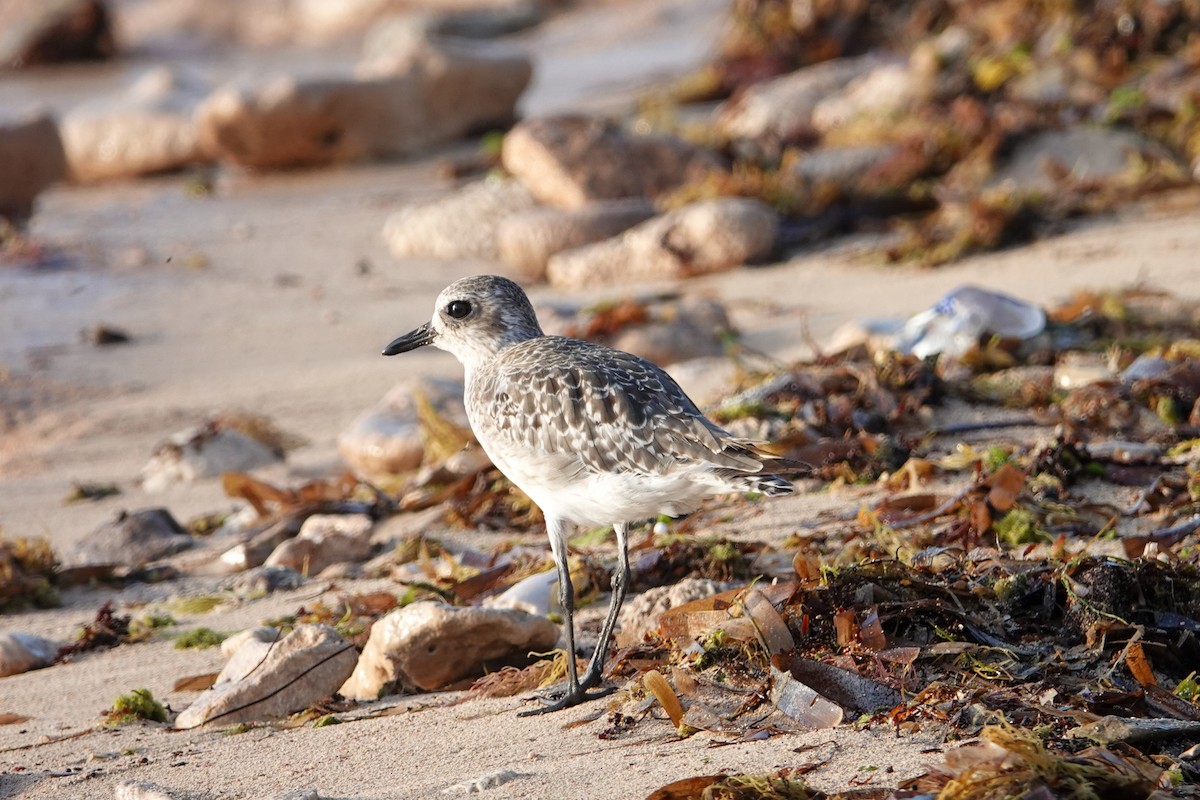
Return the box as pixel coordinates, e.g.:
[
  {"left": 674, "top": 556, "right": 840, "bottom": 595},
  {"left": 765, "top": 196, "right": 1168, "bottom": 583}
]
[{"left": 0, "top": 0, "right": 118, "bottom": 70}]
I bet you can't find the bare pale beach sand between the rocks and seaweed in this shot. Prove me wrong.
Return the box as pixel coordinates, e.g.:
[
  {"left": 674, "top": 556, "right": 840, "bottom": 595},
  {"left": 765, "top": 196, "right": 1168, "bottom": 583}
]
[{"left": 0, "top": 2, "right": 1200, "bottom": 799}]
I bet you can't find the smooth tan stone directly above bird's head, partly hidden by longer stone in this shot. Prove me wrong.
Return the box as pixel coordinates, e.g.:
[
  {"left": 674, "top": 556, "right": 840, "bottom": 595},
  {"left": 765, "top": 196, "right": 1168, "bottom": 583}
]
[{"left": 496, "top": 198, "right": 654, "bottom": 283}]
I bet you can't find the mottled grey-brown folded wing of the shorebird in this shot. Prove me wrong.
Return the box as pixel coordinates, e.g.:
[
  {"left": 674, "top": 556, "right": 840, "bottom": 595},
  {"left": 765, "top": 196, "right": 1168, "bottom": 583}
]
[{"left": 475, "top": 337, "right": 762, "bottom": 475}]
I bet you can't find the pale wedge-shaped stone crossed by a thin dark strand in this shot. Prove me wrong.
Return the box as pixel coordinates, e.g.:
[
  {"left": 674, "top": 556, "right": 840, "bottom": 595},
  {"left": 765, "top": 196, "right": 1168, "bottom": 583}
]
[{"left": 174, "top": 625, "right": 356, "bottom": 729}]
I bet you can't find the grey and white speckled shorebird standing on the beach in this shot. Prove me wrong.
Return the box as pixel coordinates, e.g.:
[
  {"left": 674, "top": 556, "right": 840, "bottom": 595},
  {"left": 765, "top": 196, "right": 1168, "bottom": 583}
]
[{"left": 383, "top": 275, "right": 794, "bottom": 714}]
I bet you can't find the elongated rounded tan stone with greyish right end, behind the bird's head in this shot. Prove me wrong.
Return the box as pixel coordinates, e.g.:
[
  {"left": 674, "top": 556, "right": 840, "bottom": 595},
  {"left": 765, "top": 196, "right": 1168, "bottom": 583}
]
[{"left": 546, "top": 198, "right": 779, "bottom": 290}]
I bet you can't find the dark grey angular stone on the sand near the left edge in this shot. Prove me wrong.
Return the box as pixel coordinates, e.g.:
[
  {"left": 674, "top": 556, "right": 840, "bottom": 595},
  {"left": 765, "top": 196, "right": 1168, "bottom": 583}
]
[{"left": 62, "top": 509, "right": 192, "bottom": 567}]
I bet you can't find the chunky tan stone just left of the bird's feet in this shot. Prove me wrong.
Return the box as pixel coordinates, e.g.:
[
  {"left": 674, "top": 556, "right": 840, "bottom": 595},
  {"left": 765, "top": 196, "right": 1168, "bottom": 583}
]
[{"left": 341, "top": 601, "right": 558, "bottom": 700}]
